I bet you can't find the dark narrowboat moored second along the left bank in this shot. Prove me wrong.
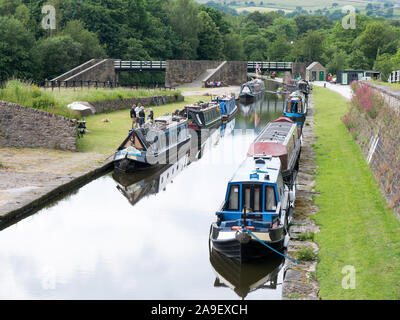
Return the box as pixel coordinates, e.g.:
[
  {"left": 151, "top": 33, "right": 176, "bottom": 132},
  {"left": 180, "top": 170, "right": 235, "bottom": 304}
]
[{"left": 180, "top": 102, "right": 222, "bottom": 131}]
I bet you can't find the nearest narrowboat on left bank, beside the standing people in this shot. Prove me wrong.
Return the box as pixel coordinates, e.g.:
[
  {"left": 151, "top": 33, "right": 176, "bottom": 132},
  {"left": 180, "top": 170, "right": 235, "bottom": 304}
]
[{"left": 114, "top": 112, "right": 191, "bottom": 172}]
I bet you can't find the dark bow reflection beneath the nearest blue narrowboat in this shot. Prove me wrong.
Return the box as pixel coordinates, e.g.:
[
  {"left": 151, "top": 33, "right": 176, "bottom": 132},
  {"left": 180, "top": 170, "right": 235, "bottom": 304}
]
[{"left": 209, "top": 246, "right": 285, "bottom": 299}]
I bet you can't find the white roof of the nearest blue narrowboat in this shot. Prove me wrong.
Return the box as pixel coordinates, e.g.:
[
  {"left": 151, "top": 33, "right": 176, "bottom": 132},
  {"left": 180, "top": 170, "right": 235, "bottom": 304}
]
[{"left": 230, "top": 156, "right": 281, "bottom": 183}]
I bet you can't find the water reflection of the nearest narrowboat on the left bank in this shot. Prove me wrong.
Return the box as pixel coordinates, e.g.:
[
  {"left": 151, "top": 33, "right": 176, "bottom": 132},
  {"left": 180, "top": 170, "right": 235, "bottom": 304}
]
[{"left": 112, "top": 153, "right": 189, "bottom": 206}]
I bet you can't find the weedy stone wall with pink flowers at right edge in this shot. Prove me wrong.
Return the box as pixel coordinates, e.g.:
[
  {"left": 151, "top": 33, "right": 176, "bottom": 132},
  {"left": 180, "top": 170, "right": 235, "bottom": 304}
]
[{"left": 342, "top": 82, "right": 400, "bottom": 217}]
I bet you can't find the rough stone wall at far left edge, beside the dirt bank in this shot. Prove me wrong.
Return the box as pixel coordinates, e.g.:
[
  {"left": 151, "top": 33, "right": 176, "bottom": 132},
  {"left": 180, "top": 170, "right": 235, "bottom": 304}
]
[{"left": 0, "top": 101, "right": 76, "bottom": 151}]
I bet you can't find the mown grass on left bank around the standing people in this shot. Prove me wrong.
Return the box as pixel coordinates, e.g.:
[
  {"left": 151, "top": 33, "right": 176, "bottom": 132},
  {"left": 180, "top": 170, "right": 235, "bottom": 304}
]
[{"left": 77, "top": 96, "right": 205, "bottom": 156}]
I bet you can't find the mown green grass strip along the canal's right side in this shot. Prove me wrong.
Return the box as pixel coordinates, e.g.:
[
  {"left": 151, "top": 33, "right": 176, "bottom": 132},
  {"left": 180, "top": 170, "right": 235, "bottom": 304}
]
[{"left": 314, "top": 88, "right": 400, "bottom": 299}]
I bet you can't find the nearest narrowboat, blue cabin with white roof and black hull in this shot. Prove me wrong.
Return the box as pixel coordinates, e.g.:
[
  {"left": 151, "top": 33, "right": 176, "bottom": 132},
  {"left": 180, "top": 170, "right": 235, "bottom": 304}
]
[{"left": 209, "top": 155, "right": 295, "bottom": 262}]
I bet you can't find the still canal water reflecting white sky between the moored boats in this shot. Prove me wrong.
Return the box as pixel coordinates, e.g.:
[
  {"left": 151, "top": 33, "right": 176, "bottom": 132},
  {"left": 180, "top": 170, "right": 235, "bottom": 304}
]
[{"left": 0, "top": 90, "right": 284, "bottom": 300}]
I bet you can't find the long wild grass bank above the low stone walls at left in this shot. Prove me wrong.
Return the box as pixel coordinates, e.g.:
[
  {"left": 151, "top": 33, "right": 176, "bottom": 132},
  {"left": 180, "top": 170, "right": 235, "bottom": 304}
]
[{"left": 0, "top": 80, "right": 180, "bottom": 119}]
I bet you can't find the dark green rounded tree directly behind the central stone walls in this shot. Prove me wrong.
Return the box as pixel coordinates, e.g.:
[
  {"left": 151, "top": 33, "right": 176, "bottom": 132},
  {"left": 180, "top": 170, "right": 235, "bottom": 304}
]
[{"left": 197, "top": 11, "right": 224, "bottom": 60}]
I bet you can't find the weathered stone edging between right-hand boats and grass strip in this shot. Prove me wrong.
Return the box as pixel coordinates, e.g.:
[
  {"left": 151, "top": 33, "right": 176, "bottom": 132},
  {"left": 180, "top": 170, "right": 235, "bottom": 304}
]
[{"left": 282, "top": 95, "right": 319, "bottom": 300}]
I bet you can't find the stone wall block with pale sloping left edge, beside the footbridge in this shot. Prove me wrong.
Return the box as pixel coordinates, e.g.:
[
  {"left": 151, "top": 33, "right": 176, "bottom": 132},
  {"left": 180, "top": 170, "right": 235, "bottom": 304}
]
[{"left": 205, "top": 61, "right": 247, "bottom": 86}]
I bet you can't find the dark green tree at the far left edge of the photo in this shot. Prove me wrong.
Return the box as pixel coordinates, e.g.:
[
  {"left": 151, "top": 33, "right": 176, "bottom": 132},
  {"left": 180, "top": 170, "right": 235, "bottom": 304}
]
[{"left": 0, "top": 16, "right": 35, "bottom": 81}]
